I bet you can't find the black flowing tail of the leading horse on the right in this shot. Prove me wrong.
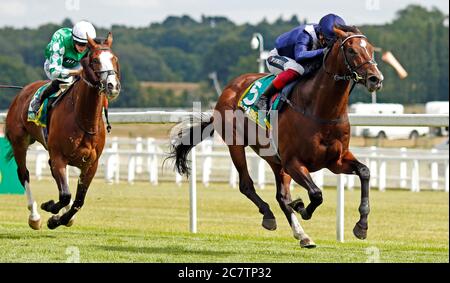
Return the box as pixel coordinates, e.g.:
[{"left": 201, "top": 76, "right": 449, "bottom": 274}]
[{"left": 166, "top": 113, "right": 214, "bottom": 176}]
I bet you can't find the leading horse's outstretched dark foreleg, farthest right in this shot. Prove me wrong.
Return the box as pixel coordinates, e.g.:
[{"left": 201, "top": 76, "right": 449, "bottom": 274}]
[{"left": 329, "top": 152, "right": 370, "bottom": 240}]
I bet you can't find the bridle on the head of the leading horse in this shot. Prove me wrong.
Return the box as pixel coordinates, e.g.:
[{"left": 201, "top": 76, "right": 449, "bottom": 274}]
[{"left": 322, "top": 34, "right": 377, "bottom": 85}]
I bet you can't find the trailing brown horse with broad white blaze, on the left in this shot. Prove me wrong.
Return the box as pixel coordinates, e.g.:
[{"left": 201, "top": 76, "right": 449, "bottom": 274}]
[{"left": 5, "top": 33, "right": 120, "bottom": 229}]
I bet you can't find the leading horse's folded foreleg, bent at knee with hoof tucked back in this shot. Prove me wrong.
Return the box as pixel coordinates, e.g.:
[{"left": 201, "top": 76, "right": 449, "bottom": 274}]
[{"left": 285, "top": 159, "right": 323, "bottom": 220}]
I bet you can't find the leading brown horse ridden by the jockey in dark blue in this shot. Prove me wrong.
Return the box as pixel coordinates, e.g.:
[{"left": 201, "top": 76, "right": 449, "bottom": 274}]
[{"left": 171, "top": 27, "right": 383, "bottom": 247}]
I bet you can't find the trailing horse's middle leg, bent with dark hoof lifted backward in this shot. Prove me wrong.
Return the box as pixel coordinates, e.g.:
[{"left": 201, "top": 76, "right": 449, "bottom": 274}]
[{"left": 41, "top": 154, "right": 71, "bottom": 214}]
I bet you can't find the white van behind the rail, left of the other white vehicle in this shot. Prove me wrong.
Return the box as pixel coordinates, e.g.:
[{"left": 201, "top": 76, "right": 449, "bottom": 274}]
[{"left": 349, "top": 103, "right": 429, "bottom": 139}]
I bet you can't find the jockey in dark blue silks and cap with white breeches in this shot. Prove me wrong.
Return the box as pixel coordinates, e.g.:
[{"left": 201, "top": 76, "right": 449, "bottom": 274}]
[{"left": 258, "top": 14, "right": 345, "bottom": 111}]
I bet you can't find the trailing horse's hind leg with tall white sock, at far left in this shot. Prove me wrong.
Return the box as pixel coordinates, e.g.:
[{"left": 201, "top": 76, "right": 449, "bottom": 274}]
[{"left": 9, "top": 133, "right": 42, "bottom": 230}]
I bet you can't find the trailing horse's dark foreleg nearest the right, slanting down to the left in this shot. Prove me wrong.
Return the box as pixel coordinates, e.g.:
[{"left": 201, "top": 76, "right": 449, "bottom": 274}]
[{"left": 47, "top": 160, "right": 98, "bottom": 229}]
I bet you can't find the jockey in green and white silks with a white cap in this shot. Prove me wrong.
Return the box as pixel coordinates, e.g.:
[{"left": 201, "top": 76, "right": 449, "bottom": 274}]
[{"left": 31, "top": 21, "right": 96, "bottom": 114}]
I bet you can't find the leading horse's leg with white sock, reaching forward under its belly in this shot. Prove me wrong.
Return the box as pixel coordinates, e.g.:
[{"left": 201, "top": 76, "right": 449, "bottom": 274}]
[{"left": 269, "top": 163, "right": 316, "bottom": 248}]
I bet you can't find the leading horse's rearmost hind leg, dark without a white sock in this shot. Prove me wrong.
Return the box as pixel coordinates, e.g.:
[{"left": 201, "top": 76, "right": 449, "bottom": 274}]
[{"left": 228, "top": 145, "right": 277, "bottom": 230}]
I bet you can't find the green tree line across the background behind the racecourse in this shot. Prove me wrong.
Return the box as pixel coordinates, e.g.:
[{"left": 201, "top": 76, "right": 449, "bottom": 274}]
[{"left": 0, "top": 5, "right": 449, "bottom": 109}]
